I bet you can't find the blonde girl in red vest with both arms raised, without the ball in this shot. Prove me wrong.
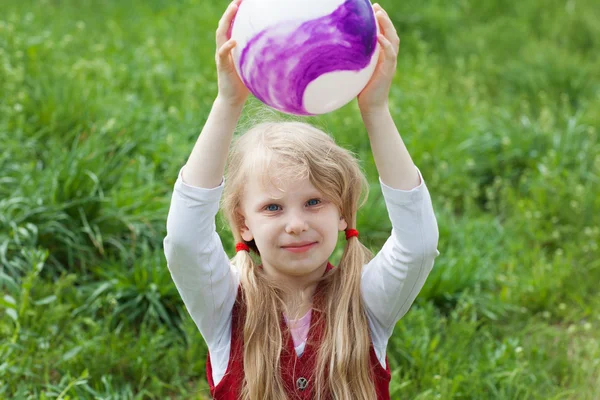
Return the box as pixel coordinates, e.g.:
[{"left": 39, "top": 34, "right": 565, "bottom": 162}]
[{"left": 164, "top": 0, "right": 439, "bottom": 400}]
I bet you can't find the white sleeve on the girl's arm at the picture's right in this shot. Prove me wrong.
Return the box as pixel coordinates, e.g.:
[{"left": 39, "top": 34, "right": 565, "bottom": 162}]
[{"left": 361, "top": 168, "right": 440, "bottom": 366}]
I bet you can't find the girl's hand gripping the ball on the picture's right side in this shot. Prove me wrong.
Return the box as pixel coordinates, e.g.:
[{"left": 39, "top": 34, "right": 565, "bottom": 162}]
[{"left": 358, "top": 3, "right": 400, "bottom": 114}]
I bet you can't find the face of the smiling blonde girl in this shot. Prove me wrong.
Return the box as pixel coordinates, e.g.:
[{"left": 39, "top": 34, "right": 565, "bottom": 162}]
[{"left": 241, "top": 170, "right": 347, "bottom": 285}]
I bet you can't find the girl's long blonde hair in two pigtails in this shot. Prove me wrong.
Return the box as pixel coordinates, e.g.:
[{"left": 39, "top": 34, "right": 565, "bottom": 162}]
[{"left": 222, "top": 122, "right": 376, "bottom": 400}]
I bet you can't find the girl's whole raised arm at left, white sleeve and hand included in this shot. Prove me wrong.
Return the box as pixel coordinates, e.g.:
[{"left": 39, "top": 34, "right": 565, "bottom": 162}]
[{"left": 164, "top": 0, "right": 248, "bottom": 382}]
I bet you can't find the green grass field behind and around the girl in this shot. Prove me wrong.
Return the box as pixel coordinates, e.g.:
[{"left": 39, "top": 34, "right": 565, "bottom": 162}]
[{"left": 0, "top": 0, "right": 600, "bottom": 400}]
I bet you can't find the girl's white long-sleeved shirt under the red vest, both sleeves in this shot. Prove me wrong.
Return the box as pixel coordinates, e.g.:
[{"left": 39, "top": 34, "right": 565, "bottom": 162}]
[{"left": 164, "top": 167, "right": 440, "bottom": 385}]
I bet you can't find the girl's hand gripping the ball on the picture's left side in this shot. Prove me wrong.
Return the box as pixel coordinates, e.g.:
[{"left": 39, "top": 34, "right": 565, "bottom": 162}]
[{"left": 215, "top": 0, "right": 250, "bottom": 105}]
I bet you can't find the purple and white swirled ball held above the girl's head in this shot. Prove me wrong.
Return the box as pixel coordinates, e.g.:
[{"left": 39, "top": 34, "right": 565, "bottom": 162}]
[{"left": 231, "top": 0, "right": 379, "bottom": 115}]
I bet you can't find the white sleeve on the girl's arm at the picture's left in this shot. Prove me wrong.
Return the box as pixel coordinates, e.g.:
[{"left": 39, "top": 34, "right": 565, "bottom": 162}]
[{"left": 163, "top": 167, "right": 239, "bottom": 382}]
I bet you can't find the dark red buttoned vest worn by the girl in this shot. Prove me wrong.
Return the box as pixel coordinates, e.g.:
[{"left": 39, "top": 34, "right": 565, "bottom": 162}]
[{"left": 206, "top": 265, "right": 391, "bottom": 400}]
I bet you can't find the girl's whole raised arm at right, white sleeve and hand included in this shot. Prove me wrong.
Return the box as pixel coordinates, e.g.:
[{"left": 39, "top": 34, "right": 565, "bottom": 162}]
[{"left": 358, "top": 4, "right": 439, "bottom": 364}]
